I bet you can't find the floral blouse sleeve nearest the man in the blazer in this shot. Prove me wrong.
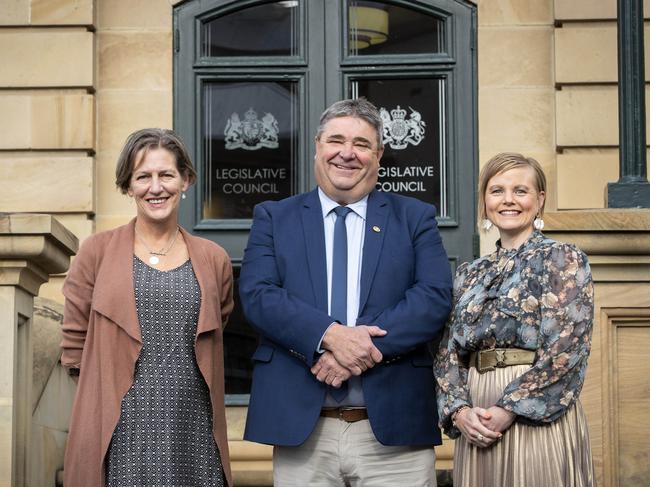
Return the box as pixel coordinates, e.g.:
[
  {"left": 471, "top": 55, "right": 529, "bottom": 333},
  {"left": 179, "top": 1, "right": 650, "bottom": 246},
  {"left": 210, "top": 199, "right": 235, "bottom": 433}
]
[{"left": 433, "top": 263, "right": 472, "bottom": 438}]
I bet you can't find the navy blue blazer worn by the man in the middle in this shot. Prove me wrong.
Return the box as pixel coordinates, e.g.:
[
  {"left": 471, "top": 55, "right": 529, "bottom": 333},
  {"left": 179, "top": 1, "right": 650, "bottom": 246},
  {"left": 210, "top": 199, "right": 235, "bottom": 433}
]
[{"left": 239, "top": 190, "right": 452, "bottom": 446}]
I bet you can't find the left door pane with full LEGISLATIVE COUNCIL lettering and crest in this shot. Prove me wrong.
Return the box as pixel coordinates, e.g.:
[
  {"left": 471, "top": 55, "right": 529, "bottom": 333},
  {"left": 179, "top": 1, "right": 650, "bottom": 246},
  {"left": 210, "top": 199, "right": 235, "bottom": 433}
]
[{"left": 202, "top": 81, "right": 298, "bottom": 219}]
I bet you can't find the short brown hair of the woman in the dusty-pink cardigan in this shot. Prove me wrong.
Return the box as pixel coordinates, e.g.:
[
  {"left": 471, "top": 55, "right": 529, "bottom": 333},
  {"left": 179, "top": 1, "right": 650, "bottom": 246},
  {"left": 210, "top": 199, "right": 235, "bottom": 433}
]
[{"left": 115, "top": 128, "right": 196, "bottom": 194}]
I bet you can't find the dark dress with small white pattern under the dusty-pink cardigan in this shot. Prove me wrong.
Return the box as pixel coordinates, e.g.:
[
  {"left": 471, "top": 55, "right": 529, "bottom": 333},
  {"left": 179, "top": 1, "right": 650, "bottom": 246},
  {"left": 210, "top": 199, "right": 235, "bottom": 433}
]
[{"left": 106, "top": 256, "right": 224, "bottom": 487}]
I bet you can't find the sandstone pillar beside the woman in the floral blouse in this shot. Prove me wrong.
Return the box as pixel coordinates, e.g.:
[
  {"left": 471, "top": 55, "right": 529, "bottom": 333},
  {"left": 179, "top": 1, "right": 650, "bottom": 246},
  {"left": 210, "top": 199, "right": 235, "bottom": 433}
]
[{"left": 544, "top": 209, "right": 650, "bottom": 485}]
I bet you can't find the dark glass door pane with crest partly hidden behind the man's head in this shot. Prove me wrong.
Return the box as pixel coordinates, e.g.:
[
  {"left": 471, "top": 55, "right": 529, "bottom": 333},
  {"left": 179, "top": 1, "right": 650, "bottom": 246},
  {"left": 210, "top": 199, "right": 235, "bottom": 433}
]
[{"left": 350, "top": 77, "right": 448, "bottom": 216}]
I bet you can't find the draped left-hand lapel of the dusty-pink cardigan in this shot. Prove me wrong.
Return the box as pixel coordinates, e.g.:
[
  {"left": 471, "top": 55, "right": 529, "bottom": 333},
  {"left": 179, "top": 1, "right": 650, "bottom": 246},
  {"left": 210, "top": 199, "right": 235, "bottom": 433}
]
[{"left": 93, "top": 218, "right": 142, "bottom": 343}]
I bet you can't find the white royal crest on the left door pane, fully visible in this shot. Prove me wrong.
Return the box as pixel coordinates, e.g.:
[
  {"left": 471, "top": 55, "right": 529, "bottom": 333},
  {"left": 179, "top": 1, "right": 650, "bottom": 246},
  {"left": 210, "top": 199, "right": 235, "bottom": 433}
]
[{"left": 224, "top": 108, "right": 280, "bottom": 150}]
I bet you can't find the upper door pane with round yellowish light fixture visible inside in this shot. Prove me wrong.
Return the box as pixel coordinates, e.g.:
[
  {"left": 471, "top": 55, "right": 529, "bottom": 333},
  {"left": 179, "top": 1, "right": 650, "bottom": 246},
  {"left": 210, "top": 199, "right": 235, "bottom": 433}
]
[{"left": 348, "top": 0, "right": 445, "bottom": 56}]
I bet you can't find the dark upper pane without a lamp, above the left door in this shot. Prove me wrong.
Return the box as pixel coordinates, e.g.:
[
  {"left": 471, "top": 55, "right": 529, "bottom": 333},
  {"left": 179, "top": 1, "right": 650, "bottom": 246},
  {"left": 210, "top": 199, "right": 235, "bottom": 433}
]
[{"left": 201, "top": 1, "right": 298, "bottom": 57}]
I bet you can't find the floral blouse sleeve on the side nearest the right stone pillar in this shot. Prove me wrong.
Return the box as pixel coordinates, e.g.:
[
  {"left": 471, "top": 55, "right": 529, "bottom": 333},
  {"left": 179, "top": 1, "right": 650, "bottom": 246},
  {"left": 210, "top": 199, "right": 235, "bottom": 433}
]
[{"left": 497, "top": 245, "right": 593, "bottom": 424}]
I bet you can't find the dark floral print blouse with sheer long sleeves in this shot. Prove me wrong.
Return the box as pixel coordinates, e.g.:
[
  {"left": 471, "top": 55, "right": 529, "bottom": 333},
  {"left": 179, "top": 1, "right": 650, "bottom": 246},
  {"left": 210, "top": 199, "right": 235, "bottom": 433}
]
[{"left": 434, "top": 232, "right": 593, "bottom": 438}]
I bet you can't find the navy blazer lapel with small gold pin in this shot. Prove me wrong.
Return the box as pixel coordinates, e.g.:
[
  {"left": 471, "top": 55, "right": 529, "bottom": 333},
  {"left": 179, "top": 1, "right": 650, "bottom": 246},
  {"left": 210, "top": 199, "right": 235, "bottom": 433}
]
[{"left": 359, "top": 191, "right": 389, "bottom": 315}]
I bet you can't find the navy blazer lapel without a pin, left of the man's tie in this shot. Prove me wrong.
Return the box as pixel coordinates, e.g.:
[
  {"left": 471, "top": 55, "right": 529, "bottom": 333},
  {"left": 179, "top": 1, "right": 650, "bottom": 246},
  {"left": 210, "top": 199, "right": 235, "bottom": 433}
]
[{"left": 302, "top": 189, "right": 328, "bottom": 313}]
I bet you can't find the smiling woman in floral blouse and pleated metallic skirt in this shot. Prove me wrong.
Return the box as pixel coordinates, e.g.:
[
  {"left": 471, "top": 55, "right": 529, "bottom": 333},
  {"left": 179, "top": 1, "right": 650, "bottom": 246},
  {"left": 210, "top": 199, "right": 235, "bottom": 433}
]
[{"left": 435, "top": 153, "right": 596, "bottom": 487}]
